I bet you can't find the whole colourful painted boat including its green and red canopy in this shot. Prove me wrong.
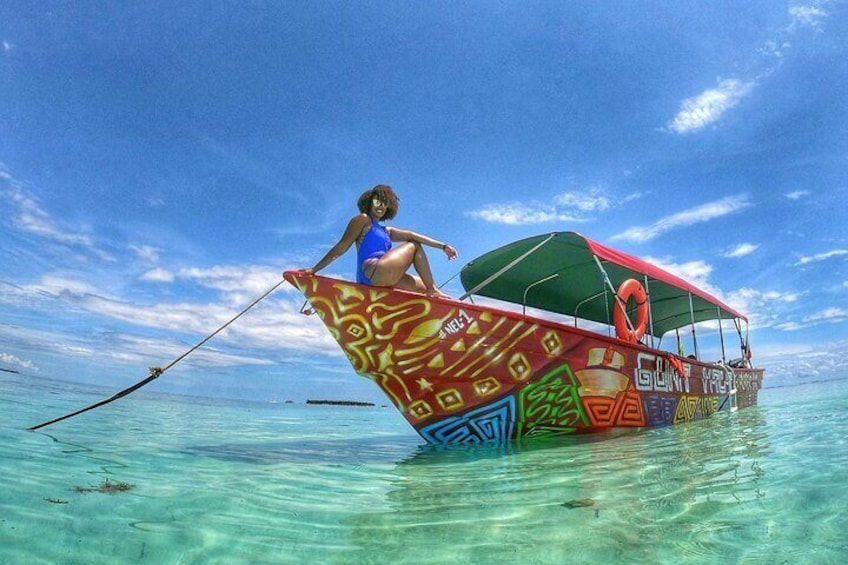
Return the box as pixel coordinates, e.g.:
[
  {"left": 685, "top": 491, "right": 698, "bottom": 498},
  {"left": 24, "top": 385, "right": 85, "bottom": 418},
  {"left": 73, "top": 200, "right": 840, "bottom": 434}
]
[{"left": 283, "top": 232, "right": 763, "bottom": 444}]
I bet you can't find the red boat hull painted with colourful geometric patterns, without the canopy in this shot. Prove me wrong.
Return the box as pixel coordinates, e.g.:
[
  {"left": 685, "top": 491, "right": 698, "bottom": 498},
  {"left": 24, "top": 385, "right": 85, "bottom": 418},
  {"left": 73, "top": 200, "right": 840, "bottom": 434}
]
[{"left": 284, "top": 271, "right": 763, "bottom": 443}]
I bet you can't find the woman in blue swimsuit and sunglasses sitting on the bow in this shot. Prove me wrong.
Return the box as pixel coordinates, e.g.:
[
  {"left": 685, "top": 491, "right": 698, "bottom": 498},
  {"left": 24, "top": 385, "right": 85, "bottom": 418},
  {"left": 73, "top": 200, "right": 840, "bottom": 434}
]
[{"left": 303, "top": 184, "right": 457, "bottom": 296}]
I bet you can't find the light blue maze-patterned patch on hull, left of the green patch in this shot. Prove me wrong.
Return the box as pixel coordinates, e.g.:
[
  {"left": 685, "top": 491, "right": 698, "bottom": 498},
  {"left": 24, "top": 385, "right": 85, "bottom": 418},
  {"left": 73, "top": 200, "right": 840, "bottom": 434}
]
[{"left": 418, "top": 395, "right": 515, "bottom": 443}]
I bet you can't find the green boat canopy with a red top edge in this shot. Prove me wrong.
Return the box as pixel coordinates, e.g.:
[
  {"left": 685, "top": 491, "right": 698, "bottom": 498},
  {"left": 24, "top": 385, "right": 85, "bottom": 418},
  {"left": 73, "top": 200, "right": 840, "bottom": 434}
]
[{"left": 460, "top": 232, "right": 747, "bottom": 336}]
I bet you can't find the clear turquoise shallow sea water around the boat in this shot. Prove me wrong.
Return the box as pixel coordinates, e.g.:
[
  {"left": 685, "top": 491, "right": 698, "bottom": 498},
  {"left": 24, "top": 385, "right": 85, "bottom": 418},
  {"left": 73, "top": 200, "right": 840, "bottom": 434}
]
[{"left": 0, "top": 373, "right": 848, "bottom": 564}]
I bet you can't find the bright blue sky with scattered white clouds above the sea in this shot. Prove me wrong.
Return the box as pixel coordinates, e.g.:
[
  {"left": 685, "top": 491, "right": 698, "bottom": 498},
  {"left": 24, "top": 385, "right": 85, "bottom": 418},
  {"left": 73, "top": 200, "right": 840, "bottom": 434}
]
[{"left": 0, "top": 0, "right": 848, "bottom": 402}]
